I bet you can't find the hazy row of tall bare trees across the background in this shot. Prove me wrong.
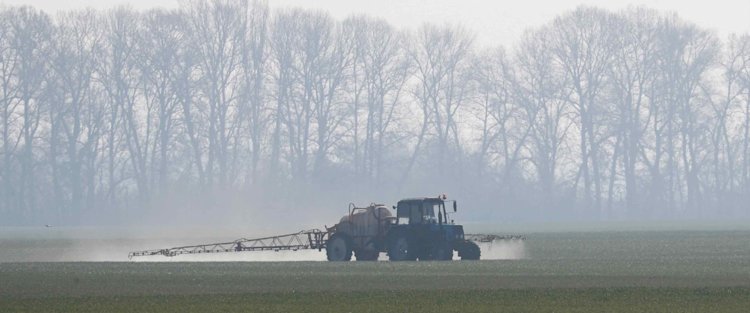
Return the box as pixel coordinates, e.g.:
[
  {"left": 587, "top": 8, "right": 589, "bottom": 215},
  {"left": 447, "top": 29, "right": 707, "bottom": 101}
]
[{"left": 0, "top": 0, "right": 750, "bottom": 224}]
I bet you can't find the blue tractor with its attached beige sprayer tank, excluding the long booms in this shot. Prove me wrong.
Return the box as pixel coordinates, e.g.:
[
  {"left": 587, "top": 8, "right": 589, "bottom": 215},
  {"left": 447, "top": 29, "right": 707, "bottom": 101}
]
[{"left": 325, "top": 196, "right": 481, "bottom": 261}]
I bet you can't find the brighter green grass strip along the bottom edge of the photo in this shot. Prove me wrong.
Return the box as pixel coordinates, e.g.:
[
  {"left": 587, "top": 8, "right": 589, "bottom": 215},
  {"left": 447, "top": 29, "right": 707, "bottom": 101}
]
[{"left": 3, "top": 288, "right": 750, "bottom": 312}]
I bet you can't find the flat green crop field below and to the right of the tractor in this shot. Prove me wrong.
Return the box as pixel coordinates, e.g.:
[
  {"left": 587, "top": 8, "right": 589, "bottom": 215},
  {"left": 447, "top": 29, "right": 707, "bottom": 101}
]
[{"left": 0, "top": 231, "right": 750, "bottom": 312}]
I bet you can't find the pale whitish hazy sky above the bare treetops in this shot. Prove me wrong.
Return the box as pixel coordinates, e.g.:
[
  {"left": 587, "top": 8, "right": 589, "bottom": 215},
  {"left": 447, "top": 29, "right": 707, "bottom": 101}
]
[{"left": 0, "top": 0, "right": 750, "bottom": 45}]
